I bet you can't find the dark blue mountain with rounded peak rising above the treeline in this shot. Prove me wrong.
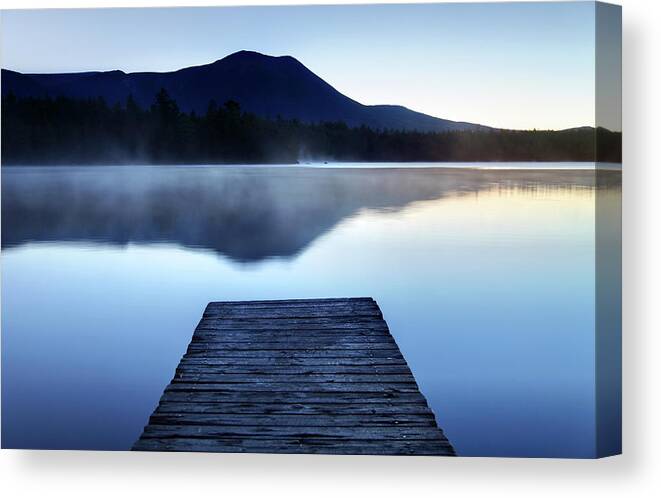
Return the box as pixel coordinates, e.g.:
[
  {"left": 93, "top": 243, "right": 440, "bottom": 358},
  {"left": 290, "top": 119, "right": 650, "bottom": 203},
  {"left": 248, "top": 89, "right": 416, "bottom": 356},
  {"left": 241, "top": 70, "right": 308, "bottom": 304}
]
[{"left": 2, "top": 51, "right": 487, "bottom": 131}]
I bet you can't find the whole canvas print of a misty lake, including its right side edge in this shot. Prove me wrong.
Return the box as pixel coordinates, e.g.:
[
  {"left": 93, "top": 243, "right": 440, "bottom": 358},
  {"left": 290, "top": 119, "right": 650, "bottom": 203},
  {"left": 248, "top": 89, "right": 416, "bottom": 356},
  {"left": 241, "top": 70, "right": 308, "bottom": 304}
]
[{"left": 0, "top": 1, "right": 622, "bottom": 458}]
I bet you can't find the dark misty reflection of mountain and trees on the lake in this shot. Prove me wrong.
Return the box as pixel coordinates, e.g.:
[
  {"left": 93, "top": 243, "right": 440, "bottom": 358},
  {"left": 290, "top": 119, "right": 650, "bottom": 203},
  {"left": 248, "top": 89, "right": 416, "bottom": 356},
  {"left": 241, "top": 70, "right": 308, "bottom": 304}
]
[{"left": 2, "top": 166, "right": 619, "bottom": 262}]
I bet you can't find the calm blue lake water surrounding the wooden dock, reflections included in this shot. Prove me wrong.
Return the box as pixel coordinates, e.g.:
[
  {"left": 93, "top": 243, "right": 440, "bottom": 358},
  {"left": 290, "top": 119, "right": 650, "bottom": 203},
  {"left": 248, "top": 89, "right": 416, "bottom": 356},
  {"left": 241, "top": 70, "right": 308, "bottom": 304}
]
[{"left": 2, "top": 164, "right": 620, "bottom": 457}]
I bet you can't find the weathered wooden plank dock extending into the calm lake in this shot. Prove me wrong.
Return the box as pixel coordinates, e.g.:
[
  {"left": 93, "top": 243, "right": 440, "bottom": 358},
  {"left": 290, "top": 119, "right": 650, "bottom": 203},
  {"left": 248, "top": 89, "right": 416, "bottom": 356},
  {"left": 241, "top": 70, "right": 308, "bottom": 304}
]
[{"left": 133, "top": 298, "right": 454, "bottom": 456}]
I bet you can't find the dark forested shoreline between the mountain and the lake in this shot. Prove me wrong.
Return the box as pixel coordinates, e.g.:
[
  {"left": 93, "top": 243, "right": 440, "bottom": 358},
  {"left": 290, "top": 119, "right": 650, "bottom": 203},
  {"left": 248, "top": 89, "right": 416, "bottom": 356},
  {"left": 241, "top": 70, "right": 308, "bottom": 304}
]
[{"left": 2, "top": 90, "right": 622, "bottom": 165}]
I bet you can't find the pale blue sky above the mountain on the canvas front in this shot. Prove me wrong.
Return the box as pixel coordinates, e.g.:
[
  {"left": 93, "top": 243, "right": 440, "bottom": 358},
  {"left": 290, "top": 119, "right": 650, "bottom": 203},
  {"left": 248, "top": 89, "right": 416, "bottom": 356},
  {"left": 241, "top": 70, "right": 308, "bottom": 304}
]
[{"left": 1, "top": 2, "right": 616, "bottom": 129}]
